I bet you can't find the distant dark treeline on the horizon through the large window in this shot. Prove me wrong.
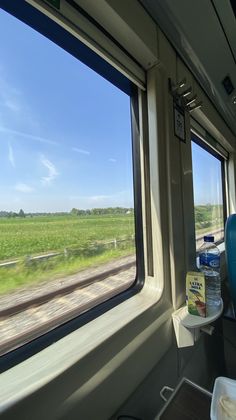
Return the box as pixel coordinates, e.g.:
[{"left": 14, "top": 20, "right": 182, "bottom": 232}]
[{"left": 0, "top": 207, "right": 134, "bottom": 218}]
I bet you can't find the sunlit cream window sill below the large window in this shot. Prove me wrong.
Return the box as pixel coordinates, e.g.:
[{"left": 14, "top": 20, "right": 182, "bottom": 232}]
[{"left": 0, "top": 278, "right": 173, "bottom": 412}]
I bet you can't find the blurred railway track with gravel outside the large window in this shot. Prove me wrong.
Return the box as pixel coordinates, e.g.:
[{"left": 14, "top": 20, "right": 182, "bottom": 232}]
[{"left": 0, "top": 256, "right": 136, "bottom": 355}]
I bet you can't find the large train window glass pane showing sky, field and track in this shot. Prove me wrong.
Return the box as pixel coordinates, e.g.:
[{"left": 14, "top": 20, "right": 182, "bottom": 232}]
[{"left": 0, "top": 10, "right": 136, "bottom": 353}]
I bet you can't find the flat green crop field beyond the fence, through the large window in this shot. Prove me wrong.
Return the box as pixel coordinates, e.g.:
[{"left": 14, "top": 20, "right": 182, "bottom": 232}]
[{"left": 0, "top": 215, "right": 134, "bottom": 261}]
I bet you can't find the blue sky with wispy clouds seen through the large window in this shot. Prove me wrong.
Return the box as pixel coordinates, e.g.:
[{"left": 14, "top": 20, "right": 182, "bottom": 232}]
[{"left": 0, "top": 10, "right": 133, "bottom": 212}]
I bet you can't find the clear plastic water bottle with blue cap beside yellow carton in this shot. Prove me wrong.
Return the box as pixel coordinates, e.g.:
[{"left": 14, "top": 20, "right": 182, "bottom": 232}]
[{"left": 199, "top": 235, "right": 221, "bottom": 311}]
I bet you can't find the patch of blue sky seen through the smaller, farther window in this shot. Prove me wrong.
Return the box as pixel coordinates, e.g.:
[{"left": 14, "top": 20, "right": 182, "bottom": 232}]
[{"left": 192, "top": 142, "right": 223, "bottom": 205}]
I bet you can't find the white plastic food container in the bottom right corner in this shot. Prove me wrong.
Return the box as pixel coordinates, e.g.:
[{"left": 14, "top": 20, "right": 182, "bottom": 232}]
[{"left": 211, "top": 376, "right": 236, "bottom": 420}]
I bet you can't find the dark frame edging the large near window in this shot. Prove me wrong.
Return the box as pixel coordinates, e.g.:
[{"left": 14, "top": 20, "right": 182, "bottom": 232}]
[{"left": 0, "top": 0, "right": 145, "bottom": 373}]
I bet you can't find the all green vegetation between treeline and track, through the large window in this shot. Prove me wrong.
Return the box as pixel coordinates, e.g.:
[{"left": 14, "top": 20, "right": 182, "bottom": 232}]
[{"left": 0, "top": 214, "right": 134, "bottom": 293}]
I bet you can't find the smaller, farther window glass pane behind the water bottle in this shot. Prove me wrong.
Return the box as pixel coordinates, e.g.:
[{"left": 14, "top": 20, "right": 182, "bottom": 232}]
[{"left": 192, "top": 141, "right": 224, "bottom": 249}]
